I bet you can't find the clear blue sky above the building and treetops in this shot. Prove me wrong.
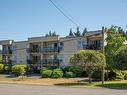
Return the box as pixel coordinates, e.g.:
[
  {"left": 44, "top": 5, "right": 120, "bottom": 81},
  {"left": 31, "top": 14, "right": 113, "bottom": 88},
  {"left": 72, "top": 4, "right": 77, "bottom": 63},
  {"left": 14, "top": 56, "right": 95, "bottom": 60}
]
[{"left": 0, "top": 0, "right": 127, "bottom": 41}]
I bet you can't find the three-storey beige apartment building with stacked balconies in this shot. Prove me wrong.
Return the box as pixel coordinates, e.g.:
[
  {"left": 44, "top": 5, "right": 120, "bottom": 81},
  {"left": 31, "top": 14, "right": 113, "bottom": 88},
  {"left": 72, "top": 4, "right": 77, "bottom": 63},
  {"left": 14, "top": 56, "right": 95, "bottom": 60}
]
[{"left": 0, "top": 30, "right": 102, "bottom": 70}]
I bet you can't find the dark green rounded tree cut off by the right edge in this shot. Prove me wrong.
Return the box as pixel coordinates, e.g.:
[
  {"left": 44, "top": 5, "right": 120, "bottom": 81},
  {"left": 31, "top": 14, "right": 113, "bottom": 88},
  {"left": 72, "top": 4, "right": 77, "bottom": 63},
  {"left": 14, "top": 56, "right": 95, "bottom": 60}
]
[{"left": 113, "top": 46, "right": 127, "bottom": 70}]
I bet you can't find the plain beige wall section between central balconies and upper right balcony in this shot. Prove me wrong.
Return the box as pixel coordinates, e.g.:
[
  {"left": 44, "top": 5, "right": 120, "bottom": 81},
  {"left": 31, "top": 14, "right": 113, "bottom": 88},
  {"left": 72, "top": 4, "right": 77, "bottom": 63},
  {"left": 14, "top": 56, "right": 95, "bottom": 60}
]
[{"left": 59, "top": 37, "right": 86, "bottom": 67}]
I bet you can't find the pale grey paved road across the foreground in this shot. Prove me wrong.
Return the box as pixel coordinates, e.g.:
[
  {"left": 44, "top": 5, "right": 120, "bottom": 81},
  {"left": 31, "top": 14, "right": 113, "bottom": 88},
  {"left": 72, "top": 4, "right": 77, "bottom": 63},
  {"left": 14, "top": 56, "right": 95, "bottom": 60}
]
[{"left": 0, "top": 84, "right": 127, "bottom": 95}]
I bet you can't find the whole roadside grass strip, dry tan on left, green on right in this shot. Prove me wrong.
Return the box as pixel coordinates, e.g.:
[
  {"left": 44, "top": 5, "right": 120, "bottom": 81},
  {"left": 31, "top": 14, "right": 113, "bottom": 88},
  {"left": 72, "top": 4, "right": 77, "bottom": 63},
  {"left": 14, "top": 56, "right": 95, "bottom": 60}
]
[{"left": 0, "top": 76, "right": 127, "bottom": 89}]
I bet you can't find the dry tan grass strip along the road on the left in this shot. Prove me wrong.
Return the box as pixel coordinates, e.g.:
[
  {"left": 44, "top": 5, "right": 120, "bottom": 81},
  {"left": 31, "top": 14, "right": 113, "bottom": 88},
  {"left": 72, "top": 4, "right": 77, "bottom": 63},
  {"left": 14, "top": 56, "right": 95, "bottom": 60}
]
[{"left": 0, "top": 77, "right": 78, "bottom": 85}]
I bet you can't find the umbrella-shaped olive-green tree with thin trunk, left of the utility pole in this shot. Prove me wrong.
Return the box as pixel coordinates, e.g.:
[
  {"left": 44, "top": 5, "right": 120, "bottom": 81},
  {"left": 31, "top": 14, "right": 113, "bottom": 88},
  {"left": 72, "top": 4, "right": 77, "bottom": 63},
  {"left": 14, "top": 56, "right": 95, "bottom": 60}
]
[{"left": 70, "top": 50, "right": 105, "bottom": 83}]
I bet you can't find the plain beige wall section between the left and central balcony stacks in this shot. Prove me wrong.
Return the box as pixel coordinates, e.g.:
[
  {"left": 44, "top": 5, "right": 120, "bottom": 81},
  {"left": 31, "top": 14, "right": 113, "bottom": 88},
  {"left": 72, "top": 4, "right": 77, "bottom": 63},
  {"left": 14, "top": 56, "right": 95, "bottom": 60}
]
[{"left": 11, "top": 41, "right": 28, "bottom": 64}]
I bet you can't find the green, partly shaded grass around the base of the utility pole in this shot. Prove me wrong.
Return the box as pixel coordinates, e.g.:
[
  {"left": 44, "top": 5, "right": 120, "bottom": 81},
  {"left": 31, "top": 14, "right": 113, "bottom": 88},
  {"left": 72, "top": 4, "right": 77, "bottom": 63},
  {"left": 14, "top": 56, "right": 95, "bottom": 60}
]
[{"left": 56, "top": 81, "right": 127, "bottom": 89}]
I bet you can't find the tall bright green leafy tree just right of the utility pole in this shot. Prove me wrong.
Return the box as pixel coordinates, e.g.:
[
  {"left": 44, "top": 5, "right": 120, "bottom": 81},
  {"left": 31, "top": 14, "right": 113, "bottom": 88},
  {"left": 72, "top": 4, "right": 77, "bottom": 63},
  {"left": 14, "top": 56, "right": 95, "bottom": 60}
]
[{"left": 105, "top": 26, "right": 125, "bottom": 69}]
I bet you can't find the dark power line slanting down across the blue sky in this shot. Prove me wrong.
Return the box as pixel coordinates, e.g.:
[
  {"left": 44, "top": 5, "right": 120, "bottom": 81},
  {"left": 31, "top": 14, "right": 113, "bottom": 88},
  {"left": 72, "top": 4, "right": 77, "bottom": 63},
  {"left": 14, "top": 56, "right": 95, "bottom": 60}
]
[{"left": 49, "top": 0, "right": 82, "bottom": 28}]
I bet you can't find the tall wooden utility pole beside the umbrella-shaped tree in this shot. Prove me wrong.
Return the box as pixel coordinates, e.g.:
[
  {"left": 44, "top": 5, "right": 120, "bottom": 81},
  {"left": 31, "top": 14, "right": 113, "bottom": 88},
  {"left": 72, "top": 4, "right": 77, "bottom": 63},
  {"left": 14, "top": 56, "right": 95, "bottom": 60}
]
[{"left": 101, "top": 26, "right": 105, "bottom": 84}]
